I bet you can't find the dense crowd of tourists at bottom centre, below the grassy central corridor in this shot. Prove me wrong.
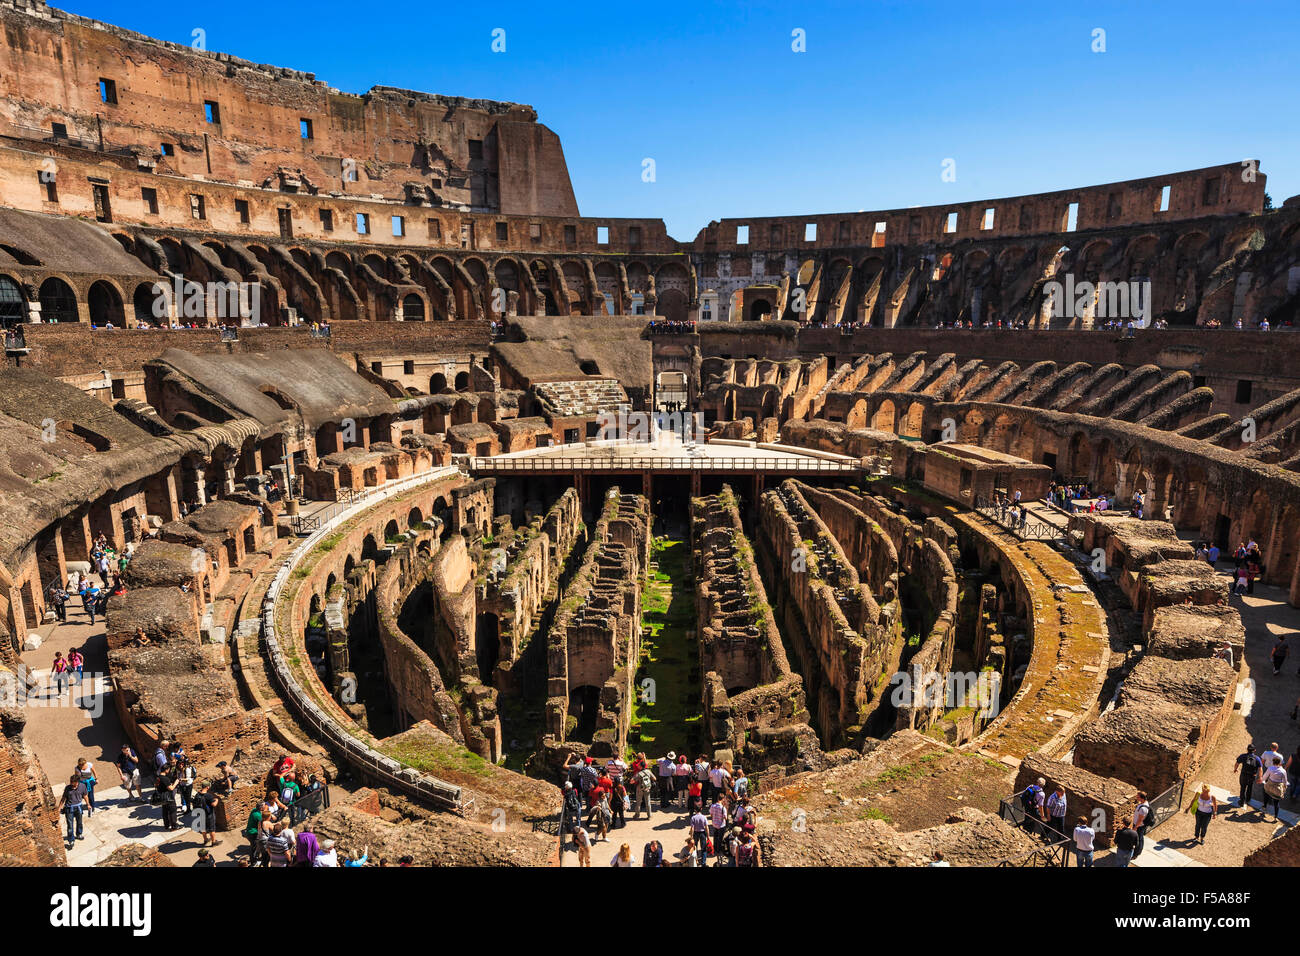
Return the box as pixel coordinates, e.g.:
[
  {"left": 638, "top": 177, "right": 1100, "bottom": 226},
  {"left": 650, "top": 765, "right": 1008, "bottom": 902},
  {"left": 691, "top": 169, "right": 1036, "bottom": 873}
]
[{"left": 560, "top": 750, "right": 763, "bottom": 866}]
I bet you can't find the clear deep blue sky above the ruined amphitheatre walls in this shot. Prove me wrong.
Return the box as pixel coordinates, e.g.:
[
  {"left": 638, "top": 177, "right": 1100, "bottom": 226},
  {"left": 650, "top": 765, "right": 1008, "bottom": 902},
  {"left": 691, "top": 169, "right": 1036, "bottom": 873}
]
[{"left": 63, "top": 0, "right": 1300, "bottom": 239}]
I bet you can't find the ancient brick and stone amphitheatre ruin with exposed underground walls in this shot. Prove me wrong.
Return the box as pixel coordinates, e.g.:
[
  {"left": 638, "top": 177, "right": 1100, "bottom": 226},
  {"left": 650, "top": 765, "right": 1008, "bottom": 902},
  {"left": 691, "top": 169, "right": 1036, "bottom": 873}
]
[{"left": 0, "top": 0, "right": 1300, "bottom": 884}]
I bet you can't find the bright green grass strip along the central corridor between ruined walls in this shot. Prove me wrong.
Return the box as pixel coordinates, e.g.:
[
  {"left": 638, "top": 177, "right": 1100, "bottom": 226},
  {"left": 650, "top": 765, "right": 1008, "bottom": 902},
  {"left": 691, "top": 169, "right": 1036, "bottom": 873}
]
[{"left": 629, "top": 537, "right": 703, "bottom": 753}]
